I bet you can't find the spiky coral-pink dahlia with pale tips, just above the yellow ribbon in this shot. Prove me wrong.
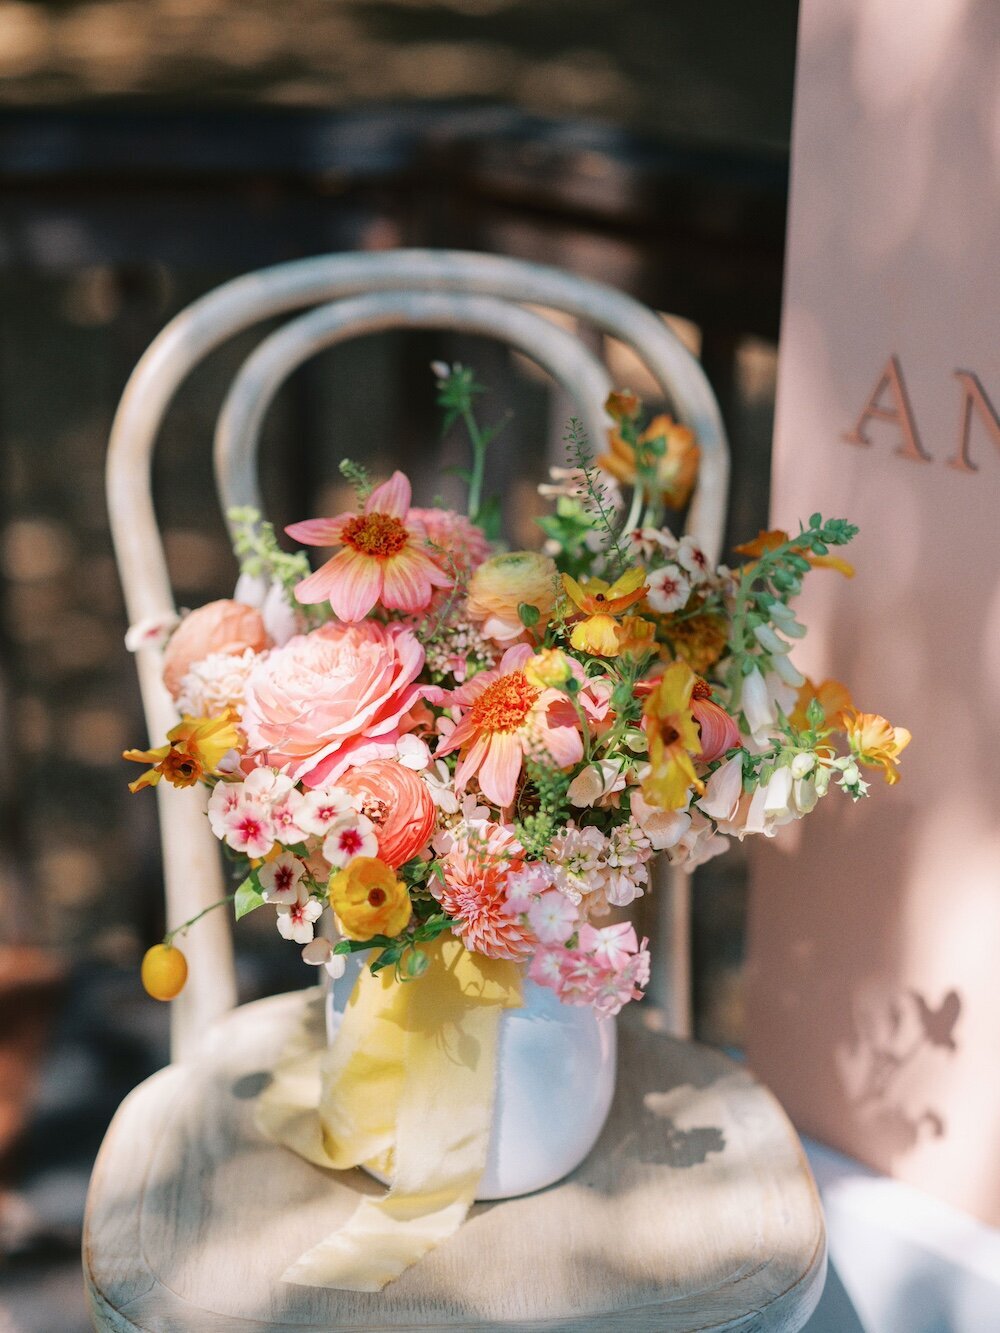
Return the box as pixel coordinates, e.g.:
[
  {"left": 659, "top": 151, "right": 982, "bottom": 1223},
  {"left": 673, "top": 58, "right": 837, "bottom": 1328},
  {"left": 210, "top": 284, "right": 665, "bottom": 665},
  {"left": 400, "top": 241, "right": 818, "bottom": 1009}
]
[{"left": 429, "top": 824, "right": 537, "bottom": 958}]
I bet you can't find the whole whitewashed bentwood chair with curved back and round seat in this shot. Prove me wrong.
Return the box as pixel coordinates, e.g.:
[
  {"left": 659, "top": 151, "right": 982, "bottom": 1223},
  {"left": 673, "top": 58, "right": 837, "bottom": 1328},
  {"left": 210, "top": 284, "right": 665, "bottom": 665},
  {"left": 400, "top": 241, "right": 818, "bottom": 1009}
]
[{"left": 84, "top": 251, "right": 825, "bottom": 1333}]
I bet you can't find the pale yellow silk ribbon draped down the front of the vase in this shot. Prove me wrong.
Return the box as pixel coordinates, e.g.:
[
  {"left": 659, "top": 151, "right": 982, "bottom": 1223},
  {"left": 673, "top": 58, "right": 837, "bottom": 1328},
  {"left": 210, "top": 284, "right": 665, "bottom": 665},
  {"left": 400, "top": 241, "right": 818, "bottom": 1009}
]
[{"left": 257, "top": 938, "right": 521, "bottom": 1292}]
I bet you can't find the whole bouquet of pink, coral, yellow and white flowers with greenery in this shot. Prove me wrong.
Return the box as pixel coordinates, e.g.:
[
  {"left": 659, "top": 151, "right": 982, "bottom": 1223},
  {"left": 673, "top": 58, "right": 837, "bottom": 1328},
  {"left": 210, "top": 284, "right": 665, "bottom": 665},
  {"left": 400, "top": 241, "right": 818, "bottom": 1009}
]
[{"left": 124, "top": 364, "right": 909, "bottom": 1014}]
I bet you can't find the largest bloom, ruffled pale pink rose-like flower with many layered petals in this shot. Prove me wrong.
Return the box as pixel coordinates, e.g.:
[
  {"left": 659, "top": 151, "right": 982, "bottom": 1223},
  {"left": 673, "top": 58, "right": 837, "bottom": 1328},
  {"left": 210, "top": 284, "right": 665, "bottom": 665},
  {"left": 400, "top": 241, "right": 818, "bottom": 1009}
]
[{"left": 243, "top": 621, "right": 424, "bottom": 786}]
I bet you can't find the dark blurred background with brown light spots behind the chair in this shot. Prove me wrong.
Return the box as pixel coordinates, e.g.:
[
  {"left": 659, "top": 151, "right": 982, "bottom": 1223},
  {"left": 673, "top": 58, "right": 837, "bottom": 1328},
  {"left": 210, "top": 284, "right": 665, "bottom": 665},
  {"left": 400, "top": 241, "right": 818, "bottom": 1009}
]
[{"left": 0, "top": 0, "right": 796, "bottom": 1333}]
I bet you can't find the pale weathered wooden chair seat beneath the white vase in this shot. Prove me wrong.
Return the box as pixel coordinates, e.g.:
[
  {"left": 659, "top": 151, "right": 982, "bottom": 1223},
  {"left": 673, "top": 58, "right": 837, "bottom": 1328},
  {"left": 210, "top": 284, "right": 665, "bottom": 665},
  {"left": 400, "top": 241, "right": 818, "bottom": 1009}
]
[{"left": 84, "top": 990, "right": 825, "bottom": 1333}]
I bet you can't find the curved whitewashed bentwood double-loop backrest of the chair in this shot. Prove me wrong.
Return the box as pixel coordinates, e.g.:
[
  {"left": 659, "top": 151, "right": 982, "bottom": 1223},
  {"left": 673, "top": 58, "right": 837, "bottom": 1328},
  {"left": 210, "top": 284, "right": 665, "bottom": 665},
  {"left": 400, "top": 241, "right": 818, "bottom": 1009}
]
[{"left": 107, "top": 251, "right": 728, "bottom": 1058}]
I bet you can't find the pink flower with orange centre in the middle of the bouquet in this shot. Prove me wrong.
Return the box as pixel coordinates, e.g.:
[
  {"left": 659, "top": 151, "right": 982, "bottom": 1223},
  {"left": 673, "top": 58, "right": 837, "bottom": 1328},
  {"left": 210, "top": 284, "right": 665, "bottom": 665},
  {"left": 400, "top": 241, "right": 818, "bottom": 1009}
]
[{"left": 437, "top": 644, "right": 583, "bottom": 809}]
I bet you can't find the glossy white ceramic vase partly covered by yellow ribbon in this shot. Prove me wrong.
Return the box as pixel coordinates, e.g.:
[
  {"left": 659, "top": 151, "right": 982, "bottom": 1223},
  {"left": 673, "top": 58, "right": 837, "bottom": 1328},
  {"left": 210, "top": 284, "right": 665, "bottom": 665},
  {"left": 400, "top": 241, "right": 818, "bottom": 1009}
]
[{"left": 327, "top": 956, "right": 617, "bottom": 1201}]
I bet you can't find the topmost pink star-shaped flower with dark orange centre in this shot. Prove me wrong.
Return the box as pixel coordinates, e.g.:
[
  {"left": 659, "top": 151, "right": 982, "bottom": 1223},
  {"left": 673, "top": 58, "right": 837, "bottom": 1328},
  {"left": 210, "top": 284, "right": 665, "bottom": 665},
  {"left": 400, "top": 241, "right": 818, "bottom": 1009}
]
[{"left": 285, "top": 472, "right": 452, "bottom": 623}]
